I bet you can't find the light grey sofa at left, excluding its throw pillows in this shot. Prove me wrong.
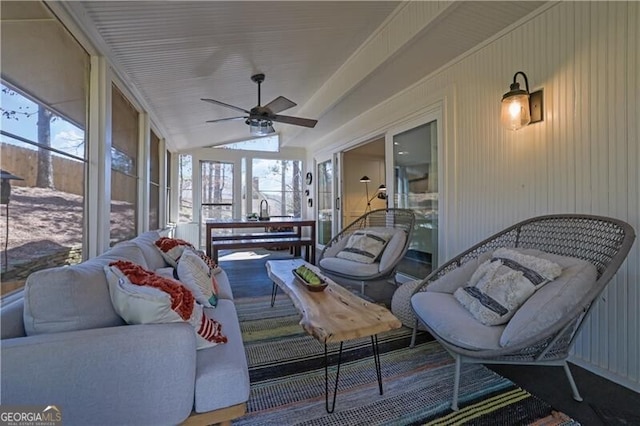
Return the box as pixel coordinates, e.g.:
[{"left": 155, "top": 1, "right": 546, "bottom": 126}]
[{"left": 0, "top": 231, "right": 249, "bottom": 425}]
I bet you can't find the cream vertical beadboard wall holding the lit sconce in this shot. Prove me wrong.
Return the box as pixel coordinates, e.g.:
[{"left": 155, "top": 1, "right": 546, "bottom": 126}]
[{"left": 317, "top": 2, "right": 640, "bottom": 391}]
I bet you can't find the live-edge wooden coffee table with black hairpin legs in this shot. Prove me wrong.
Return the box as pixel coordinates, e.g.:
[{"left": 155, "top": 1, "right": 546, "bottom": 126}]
[{"left": 266, "top": 259, "right": 402, "bottom": 413}]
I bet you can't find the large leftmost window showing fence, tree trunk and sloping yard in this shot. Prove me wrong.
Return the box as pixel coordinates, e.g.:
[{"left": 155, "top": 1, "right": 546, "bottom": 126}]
[{"left": 0, "top": 2, "right": 89, "bottom": 293}]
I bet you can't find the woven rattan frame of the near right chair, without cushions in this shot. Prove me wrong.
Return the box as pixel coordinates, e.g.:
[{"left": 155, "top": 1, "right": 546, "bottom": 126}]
[{"left": 411, "top": 214, "right": 635, "bottom": 410}]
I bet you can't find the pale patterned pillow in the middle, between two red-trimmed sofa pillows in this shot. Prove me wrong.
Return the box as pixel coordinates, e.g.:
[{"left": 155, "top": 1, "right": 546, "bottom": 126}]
[{"left": 176, "top": 249, "right": 218, "bottom": 307}]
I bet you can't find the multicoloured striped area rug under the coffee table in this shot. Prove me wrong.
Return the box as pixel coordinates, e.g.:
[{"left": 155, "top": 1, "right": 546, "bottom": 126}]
[{"left": 233, "top": 295, "right": 577, "bottom": 426}]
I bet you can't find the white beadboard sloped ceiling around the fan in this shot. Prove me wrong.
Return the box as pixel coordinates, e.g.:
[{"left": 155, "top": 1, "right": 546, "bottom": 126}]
[{"left": 64, "top": 1, "right": 543, "bottom": 151}]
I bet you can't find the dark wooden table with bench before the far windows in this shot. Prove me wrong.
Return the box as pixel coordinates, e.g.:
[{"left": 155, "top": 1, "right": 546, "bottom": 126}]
[{"left": 205, "top": 217, "right": 316, "bottom": 264}]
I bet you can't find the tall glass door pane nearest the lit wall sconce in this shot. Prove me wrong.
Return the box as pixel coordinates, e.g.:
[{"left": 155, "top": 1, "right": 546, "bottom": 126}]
[{"left": 392, "top": 120, "right": 438, "bottom": 278}]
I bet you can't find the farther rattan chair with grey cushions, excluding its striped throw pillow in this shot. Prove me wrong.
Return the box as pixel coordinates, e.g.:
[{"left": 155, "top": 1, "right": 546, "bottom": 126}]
[{"left": 318, "top": 208, "right": 415, "bottom": 294}]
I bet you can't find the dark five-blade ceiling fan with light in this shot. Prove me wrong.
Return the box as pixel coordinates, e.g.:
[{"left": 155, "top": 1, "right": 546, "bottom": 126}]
[{"left": 201, "top": 74, "right": 318, "bottom": 136}]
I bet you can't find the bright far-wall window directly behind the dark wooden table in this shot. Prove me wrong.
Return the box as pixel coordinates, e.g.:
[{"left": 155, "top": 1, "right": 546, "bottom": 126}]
[{"left": 251, "top": 159, "right": 302, "bottom": 217}]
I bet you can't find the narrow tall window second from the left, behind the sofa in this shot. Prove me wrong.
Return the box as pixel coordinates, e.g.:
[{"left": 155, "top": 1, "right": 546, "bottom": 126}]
[{"left": 110, "top": 86, "right": 138, "bottom": 245}]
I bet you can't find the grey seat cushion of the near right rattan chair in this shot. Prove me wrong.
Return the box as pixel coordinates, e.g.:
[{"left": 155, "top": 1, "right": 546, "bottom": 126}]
[{"left": 411, "top": 291, "right": 505, "bottom": 350}]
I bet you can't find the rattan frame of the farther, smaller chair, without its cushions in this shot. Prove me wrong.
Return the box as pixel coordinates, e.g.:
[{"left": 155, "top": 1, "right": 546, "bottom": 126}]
[{"left": 318, "top": 208, "right": 416, "bottom": 294}]
